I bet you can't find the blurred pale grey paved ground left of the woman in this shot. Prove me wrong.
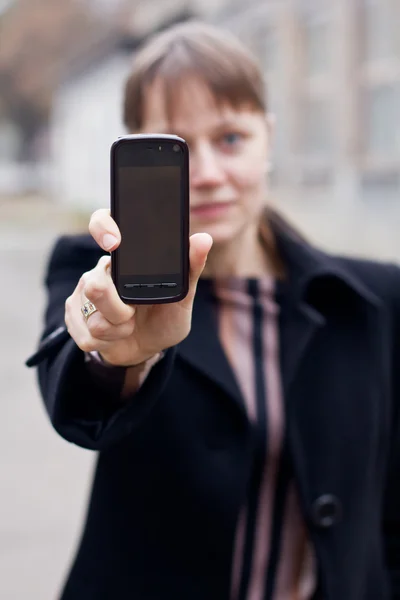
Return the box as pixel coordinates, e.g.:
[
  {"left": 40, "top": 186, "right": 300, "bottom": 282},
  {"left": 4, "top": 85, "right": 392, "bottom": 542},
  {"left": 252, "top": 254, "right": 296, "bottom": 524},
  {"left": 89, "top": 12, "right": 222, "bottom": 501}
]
[{"left": 0, "top": 202, "right": 94, "bottom": 600}]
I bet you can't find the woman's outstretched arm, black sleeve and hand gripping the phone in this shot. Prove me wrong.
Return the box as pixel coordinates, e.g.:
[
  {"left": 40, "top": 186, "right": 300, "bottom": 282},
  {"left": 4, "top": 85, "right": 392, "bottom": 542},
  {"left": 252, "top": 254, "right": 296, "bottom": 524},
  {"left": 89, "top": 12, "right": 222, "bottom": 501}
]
[{"left": 31, "top": 209, "right": 212, "bottom": 450}]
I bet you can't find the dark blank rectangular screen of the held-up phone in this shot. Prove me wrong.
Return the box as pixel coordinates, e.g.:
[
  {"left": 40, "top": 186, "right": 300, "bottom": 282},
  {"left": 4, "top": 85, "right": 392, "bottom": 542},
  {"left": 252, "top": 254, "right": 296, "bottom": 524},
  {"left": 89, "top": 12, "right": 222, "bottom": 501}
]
[{"left": 116, "top": 165, "right": 182, "bottom": 276}]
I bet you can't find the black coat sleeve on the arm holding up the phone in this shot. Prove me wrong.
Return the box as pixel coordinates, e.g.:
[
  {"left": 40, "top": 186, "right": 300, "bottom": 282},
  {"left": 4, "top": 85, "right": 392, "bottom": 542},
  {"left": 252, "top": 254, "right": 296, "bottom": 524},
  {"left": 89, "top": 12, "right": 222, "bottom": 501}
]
[{"left": 30, "top": 237, "right": 175, "bottom": 450}]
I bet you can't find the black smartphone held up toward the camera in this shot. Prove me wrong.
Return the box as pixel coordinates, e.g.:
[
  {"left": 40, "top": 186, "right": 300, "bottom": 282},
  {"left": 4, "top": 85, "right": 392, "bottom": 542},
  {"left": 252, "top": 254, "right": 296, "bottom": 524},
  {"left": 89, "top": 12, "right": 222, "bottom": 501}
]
[{"left": 111, "top": 134, "right": 189, "bottom": 304}]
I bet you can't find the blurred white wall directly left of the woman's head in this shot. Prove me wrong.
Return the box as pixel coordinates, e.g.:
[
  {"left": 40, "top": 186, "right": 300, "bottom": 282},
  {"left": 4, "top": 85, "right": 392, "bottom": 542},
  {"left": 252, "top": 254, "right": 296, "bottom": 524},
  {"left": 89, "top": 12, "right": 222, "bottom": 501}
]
[{"left": 51, "top": 54, "right": 129, "bottom": 211}]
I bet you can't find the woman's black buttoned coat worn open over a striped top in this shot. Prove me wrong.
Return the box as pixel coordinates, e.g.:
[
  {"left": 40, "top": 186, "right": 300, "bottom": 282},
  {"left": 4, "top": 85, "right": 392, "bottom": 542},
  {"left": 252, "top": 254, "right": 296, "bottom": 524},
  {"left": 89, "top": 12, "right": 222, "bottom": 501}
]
[{"left": 30, "top": 223, "right": 400, "bottom": 600}]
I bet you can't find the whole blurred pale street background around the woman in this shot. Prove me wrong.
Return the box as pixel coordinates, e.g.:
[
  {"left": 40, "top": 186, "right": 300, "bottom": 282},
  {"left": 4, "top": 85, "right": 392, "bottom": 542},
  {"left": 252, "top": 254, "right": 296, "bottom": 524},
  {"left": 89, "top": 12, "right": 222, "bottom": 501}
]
[{"left": 0, "top": 0, "right": 400, "bottom": 600}]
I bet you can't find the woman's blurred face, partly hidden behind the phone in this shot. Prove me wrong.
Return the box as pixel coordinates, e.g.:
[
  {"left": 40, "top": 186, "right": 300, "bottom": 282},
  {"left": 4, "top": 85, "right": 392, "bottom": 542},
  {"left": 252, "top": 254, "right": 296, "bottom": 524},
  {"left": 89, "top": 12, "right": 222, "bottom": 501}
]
[{"left": 138, "top": 80, "right": 269, "bottom": 244}]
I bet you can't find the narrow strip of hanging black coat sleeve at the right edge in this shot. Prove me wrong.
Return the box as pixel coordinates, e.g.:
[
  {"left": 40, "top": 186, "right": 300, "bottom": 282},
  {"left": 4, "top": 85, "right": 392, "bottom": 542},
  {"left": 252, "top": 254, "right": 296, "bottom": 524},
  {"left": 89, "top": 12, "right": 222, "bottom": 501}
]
[{"left": 383, "top": 267, "right": 400, "bottom": 600}]
